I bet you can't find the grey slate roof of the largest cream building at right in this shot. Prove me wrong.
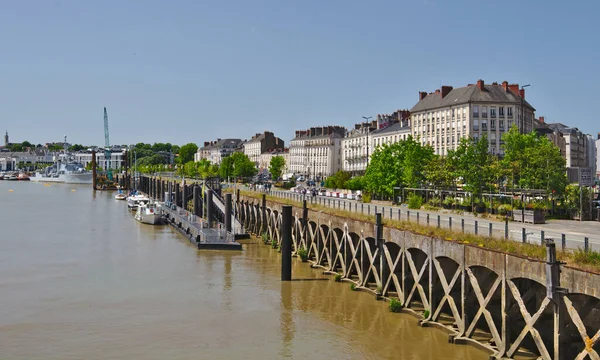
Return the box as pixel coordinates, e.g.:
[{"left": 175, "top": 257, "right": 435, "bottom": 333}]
[{"left": 410, "top": 84, "right": 535, "bottom": 113}]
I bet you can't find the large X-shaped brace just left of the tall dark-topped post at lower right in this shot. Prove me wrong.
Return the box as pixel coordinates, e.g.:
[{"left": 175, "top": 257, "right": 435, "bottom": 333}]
[{"left": 507, "top": 280, "right": 551, "bottom": 359}]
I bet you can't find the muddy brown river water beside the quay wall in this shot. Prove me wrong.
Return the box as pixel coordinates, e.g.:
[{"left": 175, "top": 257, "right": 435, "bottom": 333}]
[{"left": 0, "top": 181, "right": 488, "bottom": 360}]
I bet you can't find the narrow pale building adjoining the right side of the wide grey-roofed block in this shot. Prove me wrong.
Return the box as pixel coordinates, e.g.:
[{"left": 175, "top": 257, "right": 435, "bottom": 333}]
[{"left": 341, "top": 120, "right": 377, "bottom": 175}]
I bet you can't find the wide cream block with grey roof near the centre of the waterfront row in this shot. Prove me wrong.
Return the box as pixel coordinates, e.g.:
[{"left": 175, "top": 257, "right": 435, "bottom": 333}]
[{"left": 288, "top": 126, "right": 346, "bottom": 179}]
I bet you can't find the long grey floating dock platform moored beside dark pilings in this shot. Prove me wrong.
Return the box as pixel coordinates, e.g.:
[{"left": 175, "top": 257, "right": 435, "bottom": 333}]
[{"left": 161, "top": 203, "right": 242, "bottom": 250}]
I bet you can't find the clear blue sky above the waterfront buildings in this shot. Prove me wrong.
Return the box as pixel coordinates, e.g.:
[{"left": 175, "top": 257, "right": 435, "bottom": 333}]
[{"left": 0, "top": 0, "right": 600, "bottom": 145}]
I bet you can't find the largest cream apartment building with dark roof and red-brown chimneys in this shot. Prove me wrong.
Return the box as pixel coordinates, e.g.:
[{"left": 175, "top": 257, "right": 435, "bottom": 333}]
[{"left": 410, "top": 80, "right": 535, "bottom": 155}]
